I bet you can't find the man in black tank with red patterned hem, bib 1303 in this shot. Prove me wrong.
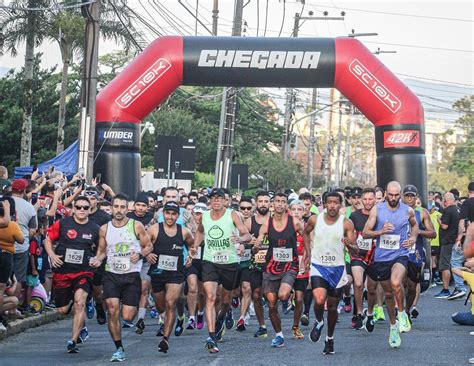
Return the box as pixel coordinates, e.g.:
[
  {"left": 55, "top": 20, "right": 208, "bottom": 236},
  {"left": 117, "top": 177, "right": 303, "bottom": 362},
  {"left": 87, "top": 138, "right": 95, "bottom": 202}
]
[{"left": 257, "top": 193, "right": 310, "bottom": 348}]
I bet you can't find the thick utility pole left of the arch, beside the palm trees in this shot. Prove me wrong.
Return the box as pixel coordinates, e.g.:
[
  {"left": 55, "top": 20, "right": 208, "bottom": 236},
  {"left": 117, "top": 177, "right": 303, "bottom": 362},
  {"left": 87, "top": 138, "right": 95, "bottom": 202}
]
[{"left": 78, "top": 0, "right": 100, "bottom": 184}]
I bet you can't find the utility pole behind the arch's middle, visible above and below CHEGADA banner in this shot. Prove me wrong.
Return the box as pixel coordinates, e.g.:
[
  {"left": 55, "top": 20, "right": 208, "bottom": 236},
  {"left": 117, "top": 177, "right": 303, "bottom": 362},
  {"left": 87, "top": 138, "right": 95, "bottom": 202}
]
[{"left": 213, "top": 0, "right": 244, "bottom": 188}]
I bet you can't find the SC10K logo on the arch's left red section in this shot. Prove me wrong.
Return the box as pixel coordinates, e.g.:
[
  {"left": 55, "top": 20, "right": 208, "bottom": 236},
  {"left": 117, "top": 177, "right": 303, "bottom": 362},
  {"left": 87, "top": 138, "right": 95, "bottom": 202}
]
[{"left": 115, "top": 58, "right": 171, "bottom": 108}]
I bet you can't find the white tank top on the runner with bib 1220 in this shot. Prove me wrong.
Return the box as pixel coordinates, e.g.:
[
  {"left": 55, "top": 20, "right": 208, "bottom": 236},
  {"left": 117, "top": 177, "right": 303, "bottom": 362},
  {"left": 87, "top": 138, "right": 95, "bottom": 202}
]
[{"left": 105, "top": 219, "right": 143, "bottom": 274}]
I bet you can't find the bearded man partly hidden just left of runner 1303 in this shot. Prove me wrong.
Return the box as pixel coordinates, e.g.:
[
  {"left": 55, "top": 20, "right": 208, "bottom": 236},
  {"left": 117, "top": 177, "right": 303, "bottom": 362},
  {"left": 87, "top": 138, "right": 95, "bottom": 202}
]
[{"left": 249, "top": 191, "right": 270, "bottom": 338}]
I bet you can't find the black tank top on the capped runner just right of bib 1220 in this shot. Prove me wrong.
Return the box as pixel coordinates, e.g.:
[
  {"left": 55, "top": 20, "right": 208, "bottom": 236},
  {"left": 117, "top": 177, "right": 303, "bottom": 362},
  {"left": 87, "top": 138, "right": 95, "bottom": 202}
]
[{"left": 149, "top": 223, "right": 187, "bottom": 275}]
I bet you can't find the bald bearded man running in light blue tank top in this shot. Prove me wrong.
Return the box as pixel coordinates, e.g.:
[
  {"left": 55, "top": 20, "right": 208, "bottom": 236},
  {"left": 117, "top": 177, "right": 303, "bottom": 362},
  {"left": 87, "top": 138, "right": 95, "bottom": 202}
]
[{"left": 362, "top": 181, "right": 419, "bottom": 348}]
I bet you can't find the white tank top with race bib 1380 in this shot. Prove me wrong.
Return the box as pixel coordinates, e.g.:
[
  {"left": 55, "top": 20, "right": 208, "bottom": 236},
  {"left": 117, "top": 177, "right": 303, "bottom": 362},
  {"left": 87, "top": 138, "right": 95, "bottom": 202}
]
[{"left": 311, "top": 214, "right": 345, "bottom": 267}]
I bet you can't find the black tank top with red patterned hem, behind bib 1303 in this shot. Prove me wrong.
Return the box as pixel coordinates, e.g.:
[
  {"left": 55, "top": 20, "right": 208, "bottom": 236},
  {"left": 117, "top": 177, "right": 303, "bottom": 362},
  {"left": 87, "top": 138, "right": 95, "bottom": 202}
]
[{"left": 266, "top": 215, "right": 299, "bottom": 274}]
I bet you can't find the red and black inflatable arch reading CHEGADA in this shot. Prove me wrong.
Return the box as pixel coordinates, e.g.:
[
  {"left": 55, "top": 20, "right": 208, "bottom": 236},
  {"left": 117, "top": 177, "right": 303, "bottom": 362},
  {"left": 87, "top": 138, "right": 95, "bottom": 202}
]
[{"left": 94, "top": 36, "right": 427, "bottom": 204}]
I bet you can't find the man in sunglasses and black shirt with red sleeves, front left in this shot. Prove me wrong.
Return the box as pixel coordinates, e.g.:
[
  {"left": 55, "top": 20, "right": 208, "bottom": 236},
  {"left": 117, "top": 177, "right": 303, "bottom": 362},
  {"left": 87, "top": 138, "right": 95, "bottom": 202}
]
[{"left": 45, "top": 196, "right": 99, "bottom": 353}]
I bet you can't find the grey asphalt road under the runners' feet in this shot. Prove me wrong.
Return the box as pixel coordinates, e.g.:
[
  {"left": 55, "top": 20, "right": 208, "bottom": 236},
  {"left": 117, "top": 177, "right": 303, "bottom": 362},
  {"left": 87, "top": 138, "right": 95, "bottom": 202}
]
[{"left": 0, "top": 287, "right": 474, "bottom": 366}]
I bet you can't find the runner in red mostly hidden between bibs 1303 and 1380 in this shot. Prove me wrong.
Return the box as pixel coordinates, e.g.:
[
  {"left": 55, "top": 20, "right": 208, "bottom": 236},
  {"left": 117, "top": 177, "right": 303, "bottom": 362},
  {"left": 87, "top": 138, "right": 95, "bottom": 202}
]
[{"left": 290, "top": 200, "right": 309, "bottom": 339}]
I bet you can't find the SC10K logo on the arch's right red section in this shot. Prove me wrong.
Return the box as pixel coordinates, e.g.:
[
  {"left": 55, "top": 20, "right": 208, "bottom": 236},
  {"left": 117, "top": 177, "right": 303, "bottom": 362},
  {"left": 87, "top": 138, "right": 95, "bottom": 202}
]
[{"left": 349, "top": 59, "right": 402, "bottom": 113}]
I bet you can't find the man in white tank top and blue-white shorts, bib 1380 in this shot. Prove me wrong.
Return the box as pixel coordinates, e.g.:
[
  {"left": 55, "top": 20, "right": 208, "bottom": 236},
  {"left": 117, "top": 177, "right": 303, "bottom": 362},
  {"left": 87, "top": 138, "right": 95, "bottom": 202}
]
[{"left": 304, "top": 192, "right": 358, "bottom": 354}]
